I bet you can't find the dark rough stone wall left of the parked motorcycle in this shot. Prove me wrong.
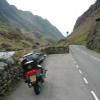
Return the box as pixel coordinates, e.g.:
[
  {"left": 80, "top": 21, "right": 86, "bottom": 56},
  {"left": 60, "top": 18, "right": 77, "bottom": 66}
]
[{"left": 0, "top": 58, "right": 22, "bottom": 96}]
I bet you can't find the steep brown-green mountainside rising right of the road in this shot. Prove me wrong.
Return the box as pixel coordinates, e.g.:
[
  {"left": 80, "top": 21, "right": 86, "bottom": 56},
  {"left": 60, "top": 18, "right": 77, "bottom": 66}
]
[{"left": 60, "top": 0, "right": 100, "bottom": 52}]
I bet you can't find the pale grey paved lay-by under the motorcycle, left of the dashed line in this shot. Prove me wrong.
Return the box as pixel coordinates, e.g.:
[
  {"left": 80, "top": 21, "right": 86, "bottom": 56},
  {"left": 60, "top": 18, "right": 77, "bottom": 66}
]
[{"left": 5, "top": 54, "right": 94, "bottom": 100}]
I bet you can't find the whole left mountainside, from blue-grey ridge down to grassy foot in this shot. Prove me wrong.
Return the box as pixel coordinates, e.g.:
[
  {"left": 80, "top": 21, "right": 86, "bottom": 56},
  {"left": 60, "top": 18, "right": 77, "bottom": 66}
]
[{"left": 0, "top": 0, "right": 63, "bottom": 49}]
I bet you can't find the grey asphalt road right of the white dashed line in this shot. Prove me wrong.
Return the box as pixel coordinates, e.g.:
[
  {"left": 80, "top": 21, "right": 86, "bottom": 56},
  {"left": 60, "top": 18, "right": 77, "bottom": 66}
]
[{"left": 70, "top": 45, "right": 100, "bottom": 100}]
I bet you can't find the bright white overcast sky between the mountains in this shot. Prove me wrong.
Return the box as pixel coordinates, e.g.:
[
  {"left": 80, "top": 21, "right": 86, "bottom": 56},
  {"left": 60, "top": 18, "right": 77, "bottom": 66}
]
[{"left": 7, "top": 0, "right": 96, "bottom": 36}]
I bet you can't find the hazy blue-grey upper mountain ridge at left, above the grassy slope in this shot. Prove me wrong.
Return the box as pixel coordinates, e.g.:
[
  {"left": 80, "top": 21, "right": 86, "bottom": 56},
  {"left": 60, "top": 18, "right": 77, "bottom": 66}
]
[{"left": 0, "top": 0, "right": 64, "bottom": 41}]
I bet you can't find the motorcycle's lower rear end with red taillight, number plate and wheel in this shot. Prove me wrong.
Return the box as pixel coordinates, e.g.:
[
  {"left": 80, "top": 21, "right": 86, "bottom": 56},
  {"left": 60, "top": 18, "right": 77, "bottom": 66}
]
[{"left": 25, "top": 65, "right": 47, "bottom": 95}]
